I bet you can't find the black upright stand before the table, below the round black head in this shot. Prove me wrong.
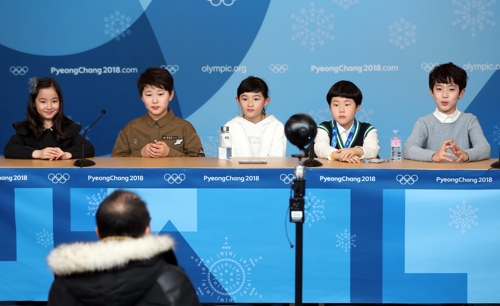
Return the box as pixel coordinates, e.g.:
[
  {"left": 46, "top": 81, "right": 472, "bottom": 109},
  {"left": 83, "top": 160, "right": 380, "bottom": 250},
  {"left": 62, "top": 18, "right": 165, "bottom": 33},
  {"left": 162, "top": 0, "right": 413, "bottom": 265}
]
[{"left": 290, "top": 149, "right": 307, "bottom": 306}]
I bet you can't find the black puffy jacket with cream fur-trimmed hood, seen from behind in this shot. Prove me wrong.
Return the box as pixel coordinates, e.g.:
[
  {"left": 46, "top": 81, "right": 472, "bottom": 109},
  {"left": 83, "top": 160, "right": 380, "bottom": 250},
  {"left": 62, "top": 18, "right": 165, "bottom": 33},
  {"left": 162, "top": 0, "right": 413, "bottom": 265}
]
[{"left": 47, "top": 235, "right": 199, "bottom": 306}]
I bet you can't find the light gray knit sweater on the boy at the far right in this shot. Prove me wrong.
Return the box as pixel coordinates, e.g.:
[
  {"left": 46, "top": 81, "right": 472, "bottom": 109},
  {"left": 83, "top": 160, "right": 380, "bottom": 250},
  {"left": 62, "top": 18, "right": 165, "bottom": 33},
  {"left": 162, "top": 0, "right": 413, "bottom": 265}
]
[{"left": 404, "top": 113, "right": 491, "bottom": 161}]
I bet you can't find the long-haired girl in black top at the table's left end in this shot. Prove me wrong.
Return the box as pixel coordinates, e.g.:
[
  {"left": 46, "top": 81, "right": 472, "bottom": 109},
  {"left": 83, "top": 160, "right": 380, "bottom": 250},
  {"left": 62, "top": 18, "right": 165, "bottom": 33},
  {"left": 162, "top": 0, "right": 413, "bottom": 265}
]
[{"left": 4, "top": 77, "right": 94, "bottom": 160}]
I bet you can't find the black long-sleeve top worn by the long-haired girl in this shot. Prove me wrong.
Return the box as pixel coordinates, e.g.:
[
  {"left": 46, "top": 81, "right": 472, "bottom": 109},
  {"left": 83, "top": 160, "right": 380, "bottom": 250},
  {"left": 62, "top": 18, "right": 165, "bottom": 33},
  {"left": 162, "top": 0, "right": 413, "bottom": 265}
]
[{"left": 4, "top": 121, "right": 95, "bottom": 159}]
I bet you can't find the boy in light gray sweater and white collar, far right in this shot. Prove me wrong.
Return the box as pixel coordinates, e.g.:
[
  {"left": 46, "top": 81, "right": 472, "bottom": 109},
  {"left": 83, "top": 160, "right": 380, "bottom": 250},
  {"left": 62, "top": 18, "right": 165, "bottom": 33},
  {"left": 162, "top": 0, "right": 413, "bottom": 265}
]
[{"left": 404, "top": 63, "right": 491, "bottom": 163}]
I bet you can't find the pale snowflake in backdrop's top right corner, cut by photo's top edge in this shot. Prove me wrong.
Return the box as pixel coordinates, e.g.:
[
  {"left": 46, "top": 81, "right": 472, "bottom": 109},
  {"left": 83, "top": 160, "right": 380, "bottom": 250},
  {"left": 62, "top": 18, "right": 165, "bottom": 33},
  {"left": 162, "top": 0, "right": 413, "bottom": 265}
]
[{"left": 451, "top": 0, "right": 496, "bottom": 37}]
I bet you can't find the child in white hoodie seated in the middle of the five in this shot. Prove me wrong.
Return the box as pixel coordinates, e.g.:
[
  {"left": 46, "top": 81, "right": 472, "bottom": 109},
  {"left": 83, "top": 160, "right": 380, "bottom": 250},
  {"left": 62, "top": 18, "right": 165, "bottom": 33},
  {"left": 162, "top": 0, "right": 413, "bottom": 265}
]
[{"left": 225, "top": 76, "right": 286, "bottom": 157}]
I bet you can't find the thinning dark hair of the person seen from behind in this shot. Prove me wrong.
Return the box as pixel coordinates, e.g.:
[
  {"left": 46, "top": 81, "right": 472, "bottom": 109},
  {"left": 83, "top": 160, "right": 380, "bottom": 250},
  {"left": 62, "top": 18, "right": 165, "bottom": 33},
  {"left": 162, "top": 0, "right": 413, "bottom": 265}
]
[{"left": 95, "top": 190, "right": 151, "bottom": 239}]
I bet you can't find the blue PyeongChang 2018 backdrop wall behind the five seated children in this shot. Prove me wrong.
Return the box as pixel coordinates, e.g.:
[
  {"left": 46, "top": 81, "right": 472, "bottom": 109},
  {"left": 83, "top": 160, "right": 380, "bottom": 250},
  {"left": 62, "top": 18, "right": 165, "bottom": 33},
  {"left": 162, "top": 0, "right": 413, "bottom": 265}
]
[{"left": 0, "top": 0, "right": 500, "bottom": 157}]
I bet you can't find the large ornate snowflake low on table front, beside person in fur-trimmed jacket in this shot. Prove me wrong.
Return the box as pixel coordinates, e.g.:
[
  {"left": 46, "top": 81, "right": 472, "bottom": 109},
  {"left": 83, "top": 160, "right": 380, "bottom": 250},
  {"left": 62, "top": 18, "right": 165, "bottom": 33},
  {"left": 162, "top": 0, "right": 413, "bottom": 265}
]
[{"left": 191, "top": 237, "right": 262, "bottom": 303}]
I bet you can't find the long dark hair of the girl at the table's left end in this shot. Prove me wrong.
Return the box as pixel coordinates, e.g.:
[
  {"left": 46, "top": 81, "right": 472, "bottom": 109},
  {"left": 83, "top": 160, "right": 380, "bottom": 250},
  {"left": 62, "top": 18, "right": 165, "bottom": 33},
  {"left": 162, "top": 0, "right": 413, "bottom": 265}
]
[{"left": 26, "top": 77, "right": 73, "bottom": 142}]
